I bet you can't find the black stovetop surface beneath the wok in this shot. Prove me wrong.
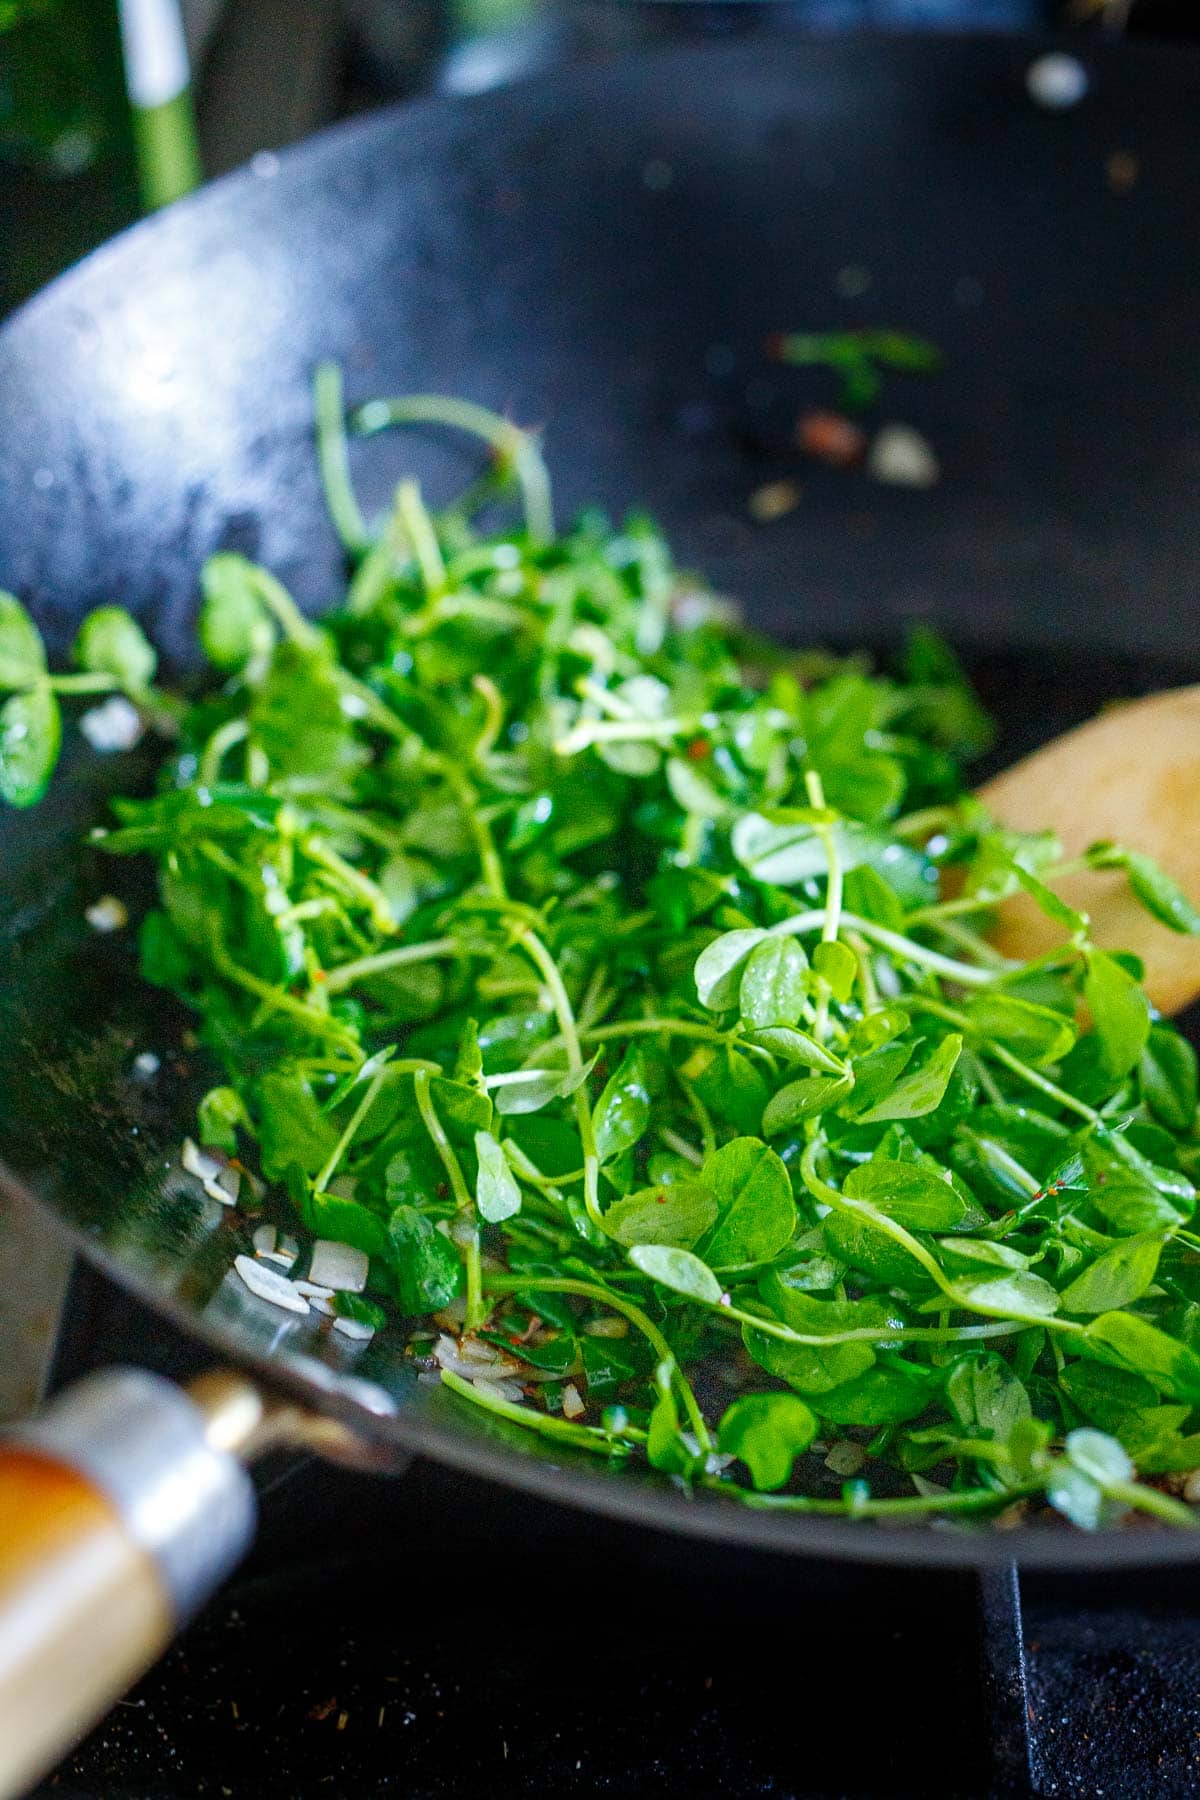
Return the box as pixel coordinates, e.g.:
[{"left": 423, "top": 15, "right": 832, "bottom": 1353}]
[{"left": 28, "top": 1276, "right": 1200, "bottom": 1800}]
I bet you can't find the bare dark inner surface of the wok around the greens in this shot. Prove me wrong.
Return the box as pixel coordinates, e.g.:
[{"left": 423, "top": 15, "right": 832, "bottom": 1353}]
[{"left": 0, "top": 40, "right": 1200, "bottom": 1566}]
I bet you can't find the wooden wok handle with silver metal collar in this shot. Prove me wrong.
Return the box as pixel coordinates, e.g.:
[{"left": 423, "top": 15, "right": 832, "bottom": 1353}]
[{"left": 0, "top": 1370, "right": 255, "bottom": 1800}]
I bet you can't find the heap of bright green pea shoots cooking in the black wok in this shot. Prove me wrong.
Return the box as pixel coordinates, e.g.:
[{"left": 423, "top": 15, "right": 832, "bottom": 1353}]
[{"left": 9, "top": 369, "right": 1200, "bottom": 1528}]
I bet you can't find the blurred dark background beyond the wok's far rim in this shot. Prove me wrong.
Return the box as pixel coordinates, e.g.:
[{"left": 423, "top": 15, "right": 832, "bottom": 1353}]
[{"left": 0, "top": 0, "right": 1200, "bottom": 315}]
